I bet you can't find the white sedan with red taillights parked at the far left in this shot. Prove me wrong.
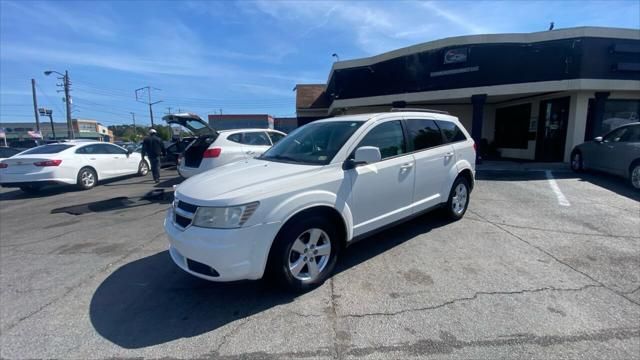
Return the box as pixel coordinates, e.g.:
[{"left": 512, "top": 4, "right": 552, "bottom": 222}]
[{"left": 0, "top": 141, "right": 149, "bottom": 192}]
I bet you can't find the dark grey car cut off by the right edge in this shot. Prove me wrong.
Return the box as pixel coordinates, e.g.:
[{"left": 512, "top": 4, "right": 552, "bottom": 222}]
[{"left": 571, "top": 122, "right": 640, "bottom": 189}]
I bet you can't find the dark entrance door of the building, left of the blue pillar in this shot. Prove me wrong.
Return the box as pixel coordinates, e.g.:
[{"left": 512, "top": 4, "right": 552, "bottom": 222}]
[{"left": 536, "top": 97, "right": 570, "bottom": 161}]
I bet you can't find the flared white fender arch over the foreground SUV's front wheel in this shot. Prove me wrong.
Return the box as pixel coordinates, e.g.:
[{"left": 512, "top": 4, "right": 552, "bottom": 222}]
[{"left": 266, "top": 190, "right": 353, "bottom": 240}]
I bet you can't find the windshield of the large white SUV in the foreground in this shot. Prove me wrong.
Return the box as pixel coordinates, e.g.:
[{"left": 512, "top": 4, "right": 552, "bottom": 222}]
[{"left": 260, "top": 121, "right": 363, "bottom": 165}]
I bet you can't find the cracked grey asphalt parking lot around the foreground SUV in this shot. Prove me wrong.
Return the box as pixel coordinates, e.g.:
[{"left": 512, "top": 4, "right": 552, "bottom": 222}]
[{"left": 0, "top": 170, "right": 640, "bottom": 359}]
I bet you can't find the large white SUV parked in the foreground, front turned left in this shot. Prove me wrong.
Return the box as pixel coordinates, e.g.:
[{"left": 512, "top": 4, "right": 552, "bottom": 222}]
[{"left": 164, "top": 110, "right": 476, "bottom": 290}]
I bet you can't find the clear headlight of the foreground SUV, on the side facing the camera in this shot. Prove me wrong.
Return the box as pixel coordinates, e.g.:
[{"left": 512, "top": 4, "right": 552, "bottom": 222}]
[{"left": 193, "top": 202, "right": 260, "bottom": 229}]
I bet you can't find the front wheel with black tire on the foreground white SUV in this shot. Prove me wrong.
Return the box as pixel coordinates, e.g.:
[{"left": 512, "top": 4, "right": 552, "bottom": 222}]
[{"left": 269, "top": 215, "right": 341, "bottom": 292}]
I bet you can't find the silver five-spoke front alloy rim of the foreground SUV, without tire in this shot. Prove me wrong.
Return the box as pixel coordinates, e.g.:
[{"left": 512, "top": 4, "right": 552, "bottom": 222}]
[{"left": 288, "top": 228, "right": 331, "bottom": 282}]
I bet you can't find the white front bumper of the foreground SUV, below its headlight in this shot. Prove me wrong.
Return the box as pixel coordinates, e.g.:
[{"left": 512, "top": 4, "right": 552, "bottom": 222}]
[{"left": 164, "top": 209, "right": 280, "bottom": 281}]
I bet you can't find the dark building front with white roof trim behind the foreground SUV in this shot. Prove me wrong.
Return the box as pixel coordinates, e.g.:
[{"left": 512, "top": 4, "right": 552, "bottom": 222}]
[{"left": 297, "top": 27, "right": 640, "bottom": 161}]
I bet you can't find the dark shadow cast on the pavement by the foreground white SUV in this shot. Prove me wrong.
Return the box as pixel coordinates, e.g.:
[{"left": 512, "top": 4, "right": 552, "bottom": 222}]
[{"left": 89, "top": 211, "right": 448, "bottom": 349}]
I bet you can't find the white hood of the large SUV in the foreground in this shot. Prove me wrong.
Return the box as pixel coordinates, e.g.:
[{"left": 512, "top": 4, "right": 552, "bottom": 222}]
[{"left": 176, "top": 159, "right": 322, "bottom": 206}]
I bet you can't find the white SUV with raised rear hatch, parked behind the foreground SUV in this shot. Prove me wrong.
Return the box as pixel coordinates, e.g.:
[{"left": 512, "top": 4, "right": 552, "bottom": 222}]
[{"left": 163, "top": 113, "right": 286, "bottom": 178}]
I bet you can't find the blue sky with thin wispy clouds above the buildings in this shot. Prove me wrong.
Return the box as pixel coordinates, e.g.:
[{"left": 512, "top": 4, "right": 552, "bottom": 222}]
[{"left": 0, "top": 0, "right": 640, "bottom": 125}]
